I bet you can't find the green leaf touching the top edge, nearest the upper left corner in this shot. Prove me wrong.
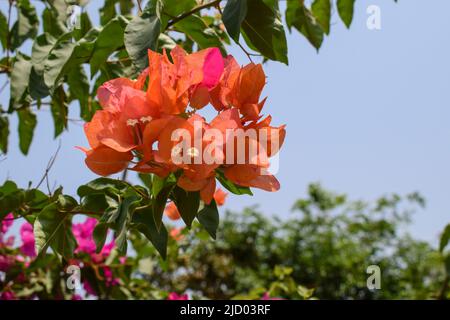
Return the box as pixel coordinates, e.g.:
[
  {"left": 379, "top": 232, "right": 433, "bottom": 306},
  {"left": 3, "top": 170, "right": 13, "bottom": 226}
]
[{"left": 11, "top": 0, "right": 39, "bottom": 50}]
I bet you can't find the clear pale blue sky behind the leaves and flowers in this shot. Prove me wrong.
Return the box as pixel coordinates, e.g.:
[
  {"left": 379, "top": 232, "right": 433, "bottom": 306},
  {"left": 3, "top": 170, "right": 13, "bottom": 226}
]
[{"left": 0, "top": 0, "right": 450, "bottom": 242}]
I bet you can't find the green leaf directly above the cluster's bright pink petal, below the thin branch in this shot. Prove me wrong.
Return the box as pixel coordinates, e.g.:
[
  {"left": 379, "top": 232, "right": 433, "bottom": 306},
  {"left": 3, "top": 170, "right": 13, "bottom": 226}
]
[{"left": 174, "top": 15, "right": 225, "bottom": 53}]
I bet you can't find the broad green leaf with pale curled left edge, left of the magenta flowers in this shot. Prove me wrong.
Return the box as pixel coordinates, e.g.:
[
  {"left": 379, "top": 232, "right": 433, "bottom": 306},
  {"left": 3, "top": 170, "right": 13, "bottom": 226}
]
[{"left": 34, "top": 203, "right": 77, "bottom": 258}]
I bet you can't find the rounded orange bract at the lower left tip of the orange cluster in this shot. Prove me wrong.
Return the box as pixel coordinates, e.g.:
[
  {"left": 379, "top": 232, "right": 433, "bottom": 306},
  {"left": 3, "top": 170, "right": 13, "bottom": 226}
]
[{"left": 85, "top": 146, "right": 133, "bottom": 176}]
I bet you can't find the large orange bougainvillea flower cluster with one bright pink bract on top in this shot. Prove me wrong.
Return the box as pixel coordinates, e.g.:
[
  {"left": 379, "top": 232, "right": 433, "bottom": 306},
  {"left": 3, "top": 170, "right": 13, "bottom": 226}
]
[{"left": 81, "top": 46, "right": 286, "bottom": 204}]
